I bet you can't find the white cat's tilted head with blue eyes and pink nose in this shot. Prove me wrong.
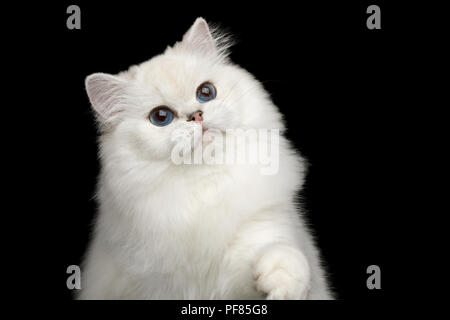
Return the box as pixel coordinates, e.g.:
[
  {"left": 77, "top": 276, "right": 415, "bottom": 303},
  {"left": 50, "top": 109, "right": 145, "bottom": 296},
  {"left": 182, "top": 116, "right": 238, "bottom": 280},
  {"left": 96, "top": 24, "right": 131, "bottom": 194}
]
[{"left": 86, "top": 18, "right": 282, "bottom": 160}]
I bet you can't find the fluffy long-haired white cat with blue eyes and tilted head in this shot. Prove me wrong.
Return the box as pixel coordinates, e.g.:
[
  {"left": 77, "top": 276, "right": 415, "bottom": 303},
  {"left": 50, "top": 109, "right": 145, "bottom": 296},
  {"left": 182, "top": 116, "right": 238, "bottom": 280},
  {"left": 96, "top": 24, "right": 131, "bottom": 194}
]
[{"left": 78, "top": 18, "right": 333, "bottom": 299}]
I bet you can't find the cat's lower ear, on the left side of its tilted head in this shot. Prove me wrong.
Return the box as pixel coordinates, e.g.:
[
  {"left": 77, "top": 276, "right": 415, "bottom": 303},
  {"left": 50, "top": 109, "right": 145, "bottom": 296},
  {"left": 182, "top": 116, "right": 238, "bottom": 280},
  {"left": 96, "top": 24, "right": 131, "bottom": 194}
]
[{"left": 85, "top": 73, "right": 128, "bottom": 120}]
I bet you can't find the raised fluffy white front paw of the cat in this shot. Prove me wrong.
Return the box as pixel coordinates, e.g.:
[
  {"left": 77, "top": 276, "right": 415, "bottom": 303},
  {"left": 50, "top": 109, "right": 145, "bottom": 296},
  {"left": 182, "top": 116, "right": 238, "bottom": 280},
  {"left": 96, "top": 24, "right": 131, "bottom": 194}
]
[{"left": 254, "top": 245, "right": 310, "bottom": 300}]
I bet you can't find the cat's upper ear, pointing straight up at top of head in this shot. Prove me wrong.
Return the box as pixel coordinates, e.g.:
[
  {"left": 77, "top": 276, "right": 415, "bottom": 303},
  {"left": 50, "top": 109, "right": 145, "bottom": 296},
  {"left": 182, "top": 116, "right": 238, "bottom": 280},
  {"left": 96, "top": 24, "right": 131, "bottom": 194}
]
[{"left": 181, "top": 18, "right": 217, "bottom": 54}]
